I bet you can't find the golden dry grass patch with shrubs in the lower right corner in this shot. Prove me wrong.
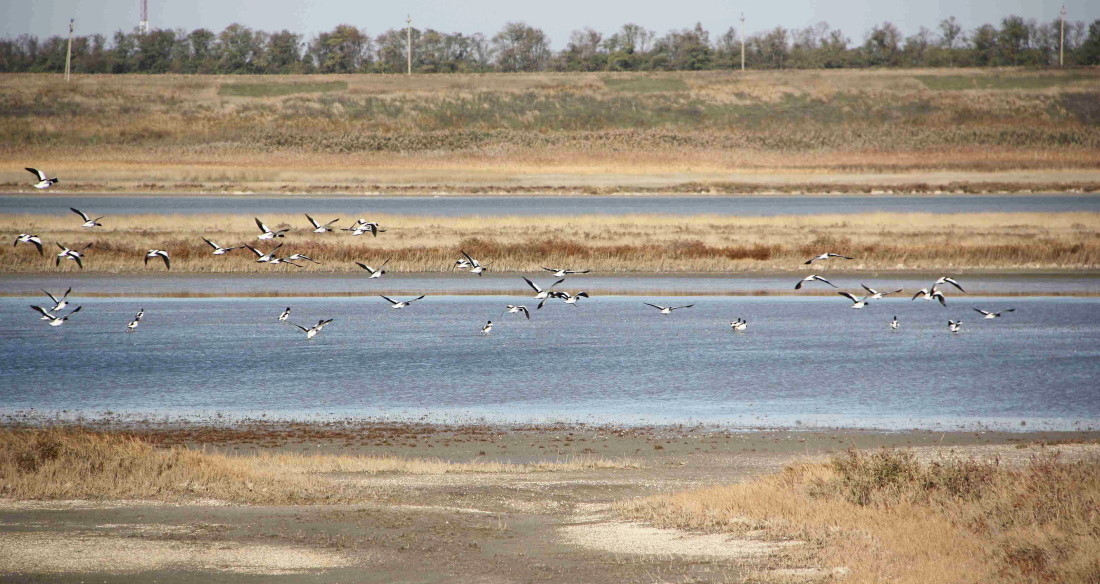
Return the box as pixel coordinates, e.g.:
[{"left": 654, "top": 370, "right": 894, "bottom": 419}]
[{"left": 619, "top": 451, "right": 1100, "bottom": 584}]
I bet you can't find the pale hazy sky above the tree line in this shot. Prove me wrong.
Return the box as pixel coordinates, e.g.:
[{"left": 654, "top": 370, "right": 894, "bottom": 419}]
[{"left": 0, "top": 0, "right": 1100, "bottom": 48}]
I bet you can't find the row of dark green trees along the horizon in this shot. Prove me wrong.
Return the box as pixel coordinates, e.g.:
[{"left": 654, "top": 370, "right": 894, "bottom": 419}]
[{"left": 0, "top": 15, "right": 1100, "bottom": 75}]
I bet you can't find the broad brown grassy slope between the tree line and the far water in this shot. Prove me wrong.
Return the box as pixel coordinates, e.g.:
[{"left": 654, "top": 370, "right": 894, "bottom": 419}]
[{"left": 0, "top": 69, "right": 1100, "bottom": 192}]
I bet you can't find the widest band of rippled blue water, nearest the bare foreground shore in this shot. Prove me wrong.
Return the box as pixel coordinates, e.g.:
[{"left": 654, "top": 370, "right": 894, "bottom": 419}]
[{"left": 0, "top": 296, "right": 1100, "bottom": 429}]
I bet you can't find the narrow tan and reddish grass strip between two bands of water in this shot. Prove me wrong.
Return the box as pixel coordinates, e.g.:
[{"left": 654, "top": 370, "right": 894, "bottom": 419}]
[{"left": 0, "top": 209, "right": 1100, "bottom": 273}]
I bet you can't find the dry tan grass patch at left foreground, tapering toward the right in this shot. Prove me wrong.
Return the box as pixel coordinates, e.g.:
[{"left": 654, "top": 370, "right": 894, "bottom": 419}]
[{"left": 0, "top": 429, "right": 641, "bottom": 504}]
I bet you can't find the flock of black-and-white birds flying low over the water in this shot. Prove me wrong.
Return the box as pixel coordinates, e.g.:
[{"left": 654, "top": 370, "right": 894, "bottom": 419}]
[{"left": 12, "top": 168, "right": 1015, "bottom": 339}]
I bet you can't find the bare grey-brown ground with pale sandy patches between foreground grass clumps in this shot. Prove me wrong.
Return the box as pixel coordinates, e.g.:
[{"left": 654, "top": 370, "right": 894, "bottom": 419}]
[{"left": 0, "top": 423, "right": 1100, "bottom": 584}]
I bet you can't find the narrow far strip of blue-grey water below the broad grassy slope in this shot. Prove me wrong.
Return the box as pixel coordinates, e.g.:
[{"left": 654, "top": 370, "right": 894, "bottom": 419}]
[{"left": 0, "top": 194, "right": 1100, "bottom": 219}]
